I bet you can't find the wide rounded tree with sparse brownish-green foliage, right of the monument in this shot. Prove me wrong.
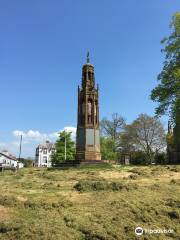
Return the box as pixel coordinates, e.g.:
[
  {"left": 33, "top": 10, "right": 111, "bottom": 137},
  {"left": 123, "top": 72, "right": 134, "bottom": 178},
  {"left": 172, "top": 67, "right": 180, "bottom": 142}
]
[{"left": 119, "top": 114, "right": 166, "bottom": 163}]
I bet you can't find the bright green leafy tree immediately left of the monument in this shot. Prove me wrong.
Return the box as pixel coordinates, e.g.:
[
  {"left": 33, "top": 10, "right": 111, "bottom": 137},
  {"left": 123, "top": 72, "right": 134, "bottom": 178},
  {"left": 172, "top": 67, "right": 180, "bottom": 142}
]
[{"left": 51, "top": 131, "right": 75, "bottom": 164}]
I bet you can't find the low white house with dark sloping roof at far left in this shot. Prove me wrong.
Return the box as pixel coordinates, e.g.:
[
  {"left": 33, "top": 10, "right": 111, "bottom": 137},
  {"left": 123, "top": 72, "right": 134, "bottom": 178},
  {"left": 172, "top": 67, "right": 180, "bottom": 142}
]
[{"left": 0, "top": 150, "right": 24, "bottom": 169}]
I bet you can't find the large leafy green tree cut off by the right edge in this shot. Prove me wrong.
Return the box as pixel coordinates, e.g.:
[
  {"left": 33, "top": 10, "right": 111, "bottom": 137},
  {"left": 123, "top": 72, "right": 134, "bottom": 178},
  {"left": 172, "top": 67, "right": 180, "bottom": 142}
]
[{"left": 151, "top": 12, "right": 180, "bottom": 124}]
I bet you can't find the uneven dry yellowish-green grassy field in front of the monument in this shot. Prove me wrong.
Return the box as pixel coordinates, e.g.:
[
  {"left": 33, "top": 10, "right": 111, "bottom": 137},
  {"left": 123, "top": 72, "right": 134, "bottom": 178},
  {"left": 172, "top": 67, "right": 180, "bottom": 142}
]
[{"left": 0, "top": 166, "right": 180, "bottom": 240}]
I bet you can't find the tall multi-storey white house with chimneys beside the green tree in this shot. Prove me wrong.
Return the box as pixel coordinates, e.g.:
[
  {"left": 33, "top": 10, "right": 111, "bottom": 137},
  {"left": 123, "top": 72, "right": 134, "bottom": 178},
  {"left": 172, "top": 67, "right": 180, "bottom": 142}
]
[{"left": 35, "top": 141, "right": 55, "bottom": 167}]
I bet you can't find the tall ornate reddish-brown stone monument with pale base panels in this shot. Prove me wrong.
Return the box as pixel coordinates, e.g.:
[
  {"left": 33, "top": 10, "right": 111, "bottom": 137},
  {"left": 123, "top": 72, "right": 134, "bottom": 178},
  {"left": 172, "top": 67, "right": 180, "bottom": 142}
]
[{"left": 76, "top": 53, "right": 101, "bottom": 162}]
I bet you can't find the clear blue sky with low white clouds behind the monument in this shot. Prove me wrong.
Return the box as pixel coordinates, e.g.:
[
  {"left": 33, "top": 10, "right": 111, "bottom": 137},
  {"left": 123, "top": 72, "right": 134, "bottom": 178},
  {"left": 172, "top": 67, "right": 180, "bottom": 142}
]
[{"left": 0, "top": 0, "right": 180, "bottom": 156}]
